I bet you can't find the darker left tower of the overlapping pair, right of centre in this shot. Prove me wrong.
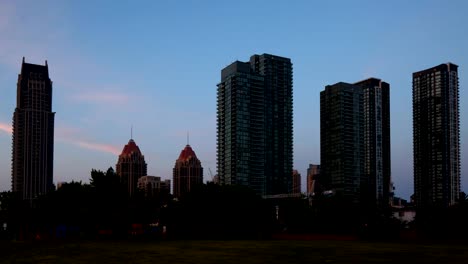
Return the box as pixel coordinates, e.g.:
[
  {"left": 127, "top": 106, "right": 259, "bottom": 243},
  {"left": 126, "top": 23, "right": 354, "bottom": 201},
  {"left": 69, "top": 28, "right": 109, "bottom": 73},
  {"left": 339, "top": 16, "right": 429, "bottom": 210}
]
[{"left": 319, "top": 82, "right": 366, "bottom": 204}]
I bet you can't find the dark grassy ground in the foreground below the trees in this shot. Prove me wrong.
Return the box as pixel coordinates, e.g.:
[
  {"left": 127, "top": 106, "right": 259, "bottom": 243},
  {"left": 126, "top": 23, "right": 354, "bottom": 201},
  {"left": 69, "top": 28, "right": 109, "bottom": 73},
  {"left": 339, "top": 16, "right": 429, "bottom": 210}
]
[{"left": 0, "top": 240, "right": 468, "bottom": 264}]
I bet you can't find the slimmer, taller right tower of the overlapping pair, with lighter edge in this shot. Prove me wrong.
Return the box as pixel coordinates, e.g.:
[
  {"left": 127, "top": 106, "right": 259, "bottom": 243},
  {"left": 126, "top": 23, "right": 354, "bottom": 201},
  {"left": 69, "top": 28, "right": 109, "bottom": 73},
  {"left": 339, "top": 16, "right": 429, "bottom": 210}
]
[{"left": 355, "top": 78, "right": 392, "bottom": 207}]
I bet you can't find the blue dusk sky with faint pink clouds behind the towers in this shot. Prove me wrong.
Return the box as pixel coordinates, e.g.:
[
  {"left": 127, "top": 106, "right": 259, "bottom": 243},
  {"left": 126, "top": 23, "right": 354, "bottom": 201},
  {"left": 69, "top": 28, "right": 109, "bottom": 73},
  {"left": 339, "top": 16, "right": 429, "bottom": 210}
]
[{"left": 0, "top": 0, "right": 468, "bottom": 199}]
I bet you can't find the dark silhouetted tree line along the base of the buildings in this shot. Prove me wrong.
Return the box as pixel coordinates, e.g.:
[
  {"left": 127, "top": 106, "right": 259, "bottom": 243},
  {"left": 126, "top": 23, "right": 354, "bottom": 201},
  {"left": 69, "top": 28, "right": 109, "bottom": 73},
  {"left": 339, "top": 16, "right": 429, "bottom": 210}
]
[{"left": 0, "top": 168, "right": 468, "bottom": 240}]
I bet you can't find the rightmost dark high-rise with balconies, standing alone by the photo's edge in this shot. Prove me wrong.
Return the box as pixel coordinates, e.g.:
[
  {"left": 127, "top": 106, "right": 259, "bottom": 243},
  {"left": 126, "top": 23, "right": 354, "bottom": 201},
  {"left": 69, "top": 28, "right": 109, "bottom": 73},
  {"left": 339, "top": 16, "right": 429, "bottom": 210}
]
[{"left": 413, "top": 63, "right": 460, "bottom": 209}]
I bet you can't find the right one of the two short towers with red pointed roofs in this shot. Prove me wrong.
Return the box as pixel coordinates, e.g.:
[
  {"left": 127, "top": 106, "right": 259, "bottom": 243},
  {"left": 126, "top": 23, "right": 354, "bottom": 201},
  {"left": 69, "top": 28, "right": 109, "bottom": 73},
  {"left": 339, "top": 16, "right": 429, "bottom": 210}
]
[{"left": 172, "top": 145, "right": 203, "bottom": 198}]
